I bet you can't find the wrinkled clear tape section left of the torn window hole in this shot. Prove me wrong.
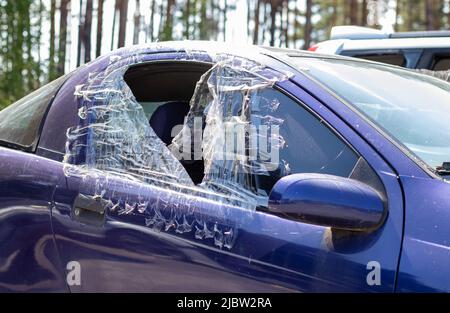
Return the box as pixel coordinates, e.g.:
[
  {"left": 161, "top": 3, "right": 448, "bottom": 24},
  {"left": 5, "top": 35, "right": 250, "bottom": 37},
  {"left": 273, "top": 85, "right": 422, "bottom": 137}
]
[{"left": 64, "top": 54, "right": 193, "bottom": 186}]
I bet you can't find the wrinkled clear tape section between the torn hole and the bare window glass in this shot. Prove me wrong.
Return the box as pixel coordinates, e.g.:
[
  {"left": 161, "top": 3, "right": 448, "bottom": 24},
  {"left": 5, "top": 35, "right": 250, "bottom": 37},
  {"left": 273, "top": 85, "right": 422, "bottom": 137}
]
[{"left": 170, "top": 56, "right": 287, "bottom": 208}]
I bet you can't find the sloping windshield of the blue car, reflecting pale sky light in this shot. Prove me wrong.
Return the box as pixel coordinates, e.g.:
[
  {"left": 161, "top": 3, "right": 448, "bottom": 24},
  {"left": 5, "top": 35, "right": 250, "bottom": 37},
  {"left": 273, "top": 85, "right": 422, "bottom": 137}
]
[{"left": 291, "top": 57, "right": 450, "bottom": 168}]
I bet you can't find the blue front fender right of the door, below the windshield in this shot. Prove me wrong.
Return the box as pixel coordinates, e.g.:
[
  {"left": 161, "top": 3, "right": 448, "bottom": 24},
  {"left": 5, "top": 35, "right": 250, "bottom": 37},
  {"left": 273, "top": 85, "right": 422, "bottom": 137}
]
[{"left": 397, "top": 176, "right": 450, "bottom": 292}]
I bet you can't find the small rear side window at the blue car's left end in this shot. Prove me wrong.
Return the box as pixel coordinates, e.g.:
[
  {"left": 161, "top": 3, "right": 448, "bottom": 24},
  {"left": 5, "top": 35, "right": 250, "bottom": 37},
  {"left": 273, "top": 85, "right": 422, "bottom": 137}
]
[{"left": 0, "top": 76, "right": 66, "bottom": 150}]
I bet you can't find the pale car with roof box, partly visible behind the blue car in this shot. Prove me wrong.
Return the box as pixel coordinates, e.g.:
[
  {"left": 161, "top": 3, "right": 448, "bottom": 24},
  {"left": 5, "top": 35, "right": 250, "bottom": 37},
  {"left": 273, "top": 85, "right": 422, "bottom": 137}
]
[{"left": 309, "top": 26, "right": 450, "bottom": 71}]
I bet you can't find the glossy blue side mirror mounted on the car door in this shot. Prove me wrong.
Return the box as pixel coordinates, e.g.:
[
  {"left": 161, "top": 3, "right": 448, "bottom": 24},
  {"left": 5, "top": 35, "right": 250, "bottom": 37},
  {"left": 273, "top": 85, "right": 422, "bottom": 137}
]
[{"left": 268, "top": 174, "right": 386, "bottom": 231}]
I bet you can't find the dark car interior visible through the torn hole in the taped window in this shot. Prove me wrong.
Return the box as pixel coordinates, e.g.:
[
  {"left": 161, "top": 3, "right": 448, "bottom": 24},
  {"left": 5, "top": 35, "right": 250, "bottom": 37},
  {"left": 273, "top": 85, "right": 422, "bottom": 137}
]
[{"left": 124, "top": 61, "right": 212, "bottom": 184}]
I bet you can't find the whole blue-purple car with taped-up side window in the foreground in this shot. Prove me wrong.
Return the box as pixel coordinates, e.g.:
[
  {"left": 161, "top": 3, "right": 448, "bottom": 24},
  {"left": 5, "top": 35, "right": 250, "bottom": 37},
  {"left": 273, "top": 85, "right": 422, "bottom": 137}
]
[{"left": 0, "top": 42, "right": 450, "bottom": 292}]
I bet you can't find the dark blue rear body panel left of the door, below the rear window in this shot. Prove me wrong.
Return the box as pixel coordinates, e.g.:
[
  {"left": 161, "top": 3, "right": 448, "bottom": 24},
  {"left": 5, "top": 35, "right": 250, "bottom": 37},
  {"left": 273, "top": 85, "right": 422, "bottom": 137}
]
[{"left": 0, "top": 148, "right": 68, "bottom": 292}]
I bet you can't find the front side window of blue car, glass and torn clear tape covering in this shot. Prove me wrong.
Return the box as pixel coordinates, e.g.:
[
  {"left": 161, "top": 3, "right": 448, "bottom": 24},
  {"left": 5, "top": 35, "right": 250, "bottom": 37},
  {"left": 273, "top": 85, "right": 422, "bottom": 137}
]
[{"left": 64, "top": 49, "right": 357, "bottom": 212}]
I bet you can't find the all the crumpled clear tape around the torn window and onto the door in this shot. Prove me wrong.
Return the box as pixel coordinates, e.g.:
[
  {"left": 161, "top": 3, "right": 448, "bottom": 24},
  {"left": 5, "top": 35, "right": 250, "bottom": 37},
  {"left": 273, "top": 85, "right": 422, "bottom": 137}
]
[{"left": 63, "top": 46, "right": 289, "bottom": 249}]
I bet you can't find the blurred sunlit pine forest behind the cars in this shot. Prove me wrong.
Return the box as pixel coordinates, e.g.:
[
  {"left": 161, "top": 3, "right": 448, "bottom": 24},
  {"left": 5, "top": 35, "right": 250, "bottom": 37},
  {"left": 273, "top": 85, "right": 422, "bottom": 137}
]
[{"left": 0, "top": 0, "right": 450, "bottom": 109}]
